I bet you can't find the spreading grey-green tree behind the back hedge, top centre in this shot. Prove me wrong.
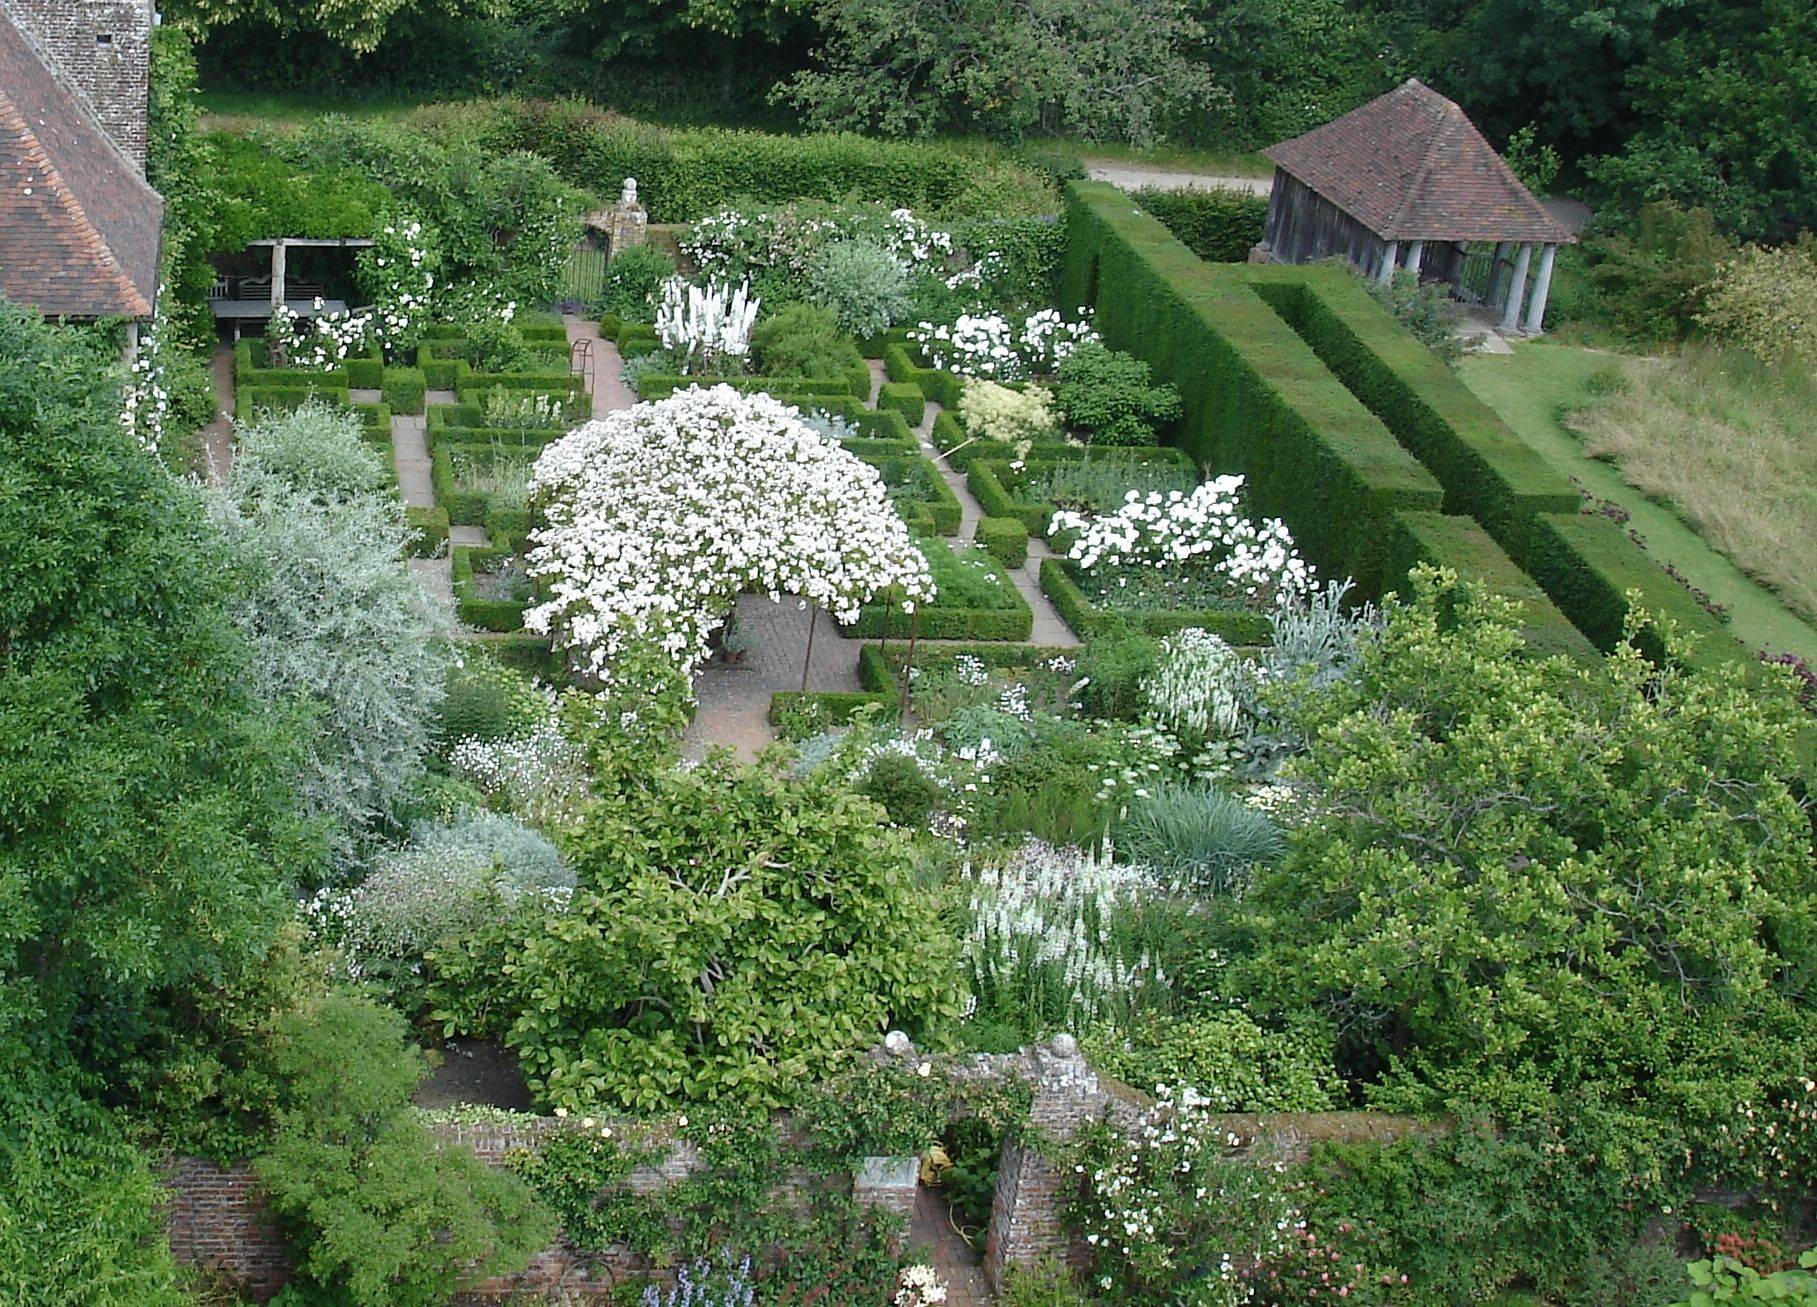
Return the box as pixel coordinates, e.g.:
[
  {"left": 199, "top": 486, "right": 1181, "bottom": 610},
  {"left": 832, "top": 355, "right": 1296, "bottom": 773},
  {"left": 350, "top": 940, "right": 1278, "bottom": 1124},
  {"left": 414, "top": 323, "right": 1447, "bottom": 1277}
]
[{"left": 776, "top": 0, "right": 1210, "bottom": 145}]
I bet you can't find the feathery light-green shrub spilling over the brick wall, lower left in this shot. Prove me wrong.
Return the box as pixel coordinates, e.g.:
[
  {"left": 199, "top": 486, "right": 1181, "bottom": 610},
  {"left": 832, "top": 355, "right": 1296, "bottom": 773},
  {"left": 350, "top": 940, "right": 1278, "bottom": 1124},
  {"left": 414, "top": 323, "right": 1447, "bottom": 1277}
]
[{"left": 253, "top": 994, "right": 554, "bottom": 1307}]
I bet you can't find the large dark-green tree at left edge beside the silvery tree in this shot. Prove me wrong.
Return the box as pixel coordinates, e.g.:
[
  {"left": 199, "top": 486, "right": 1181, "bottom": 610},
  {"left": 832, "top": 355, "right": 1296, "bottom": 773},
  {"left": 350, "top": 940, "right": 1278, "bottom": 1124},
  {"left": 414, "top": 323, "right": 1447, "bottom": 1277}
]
[{"left": 0, "top": 302, "right": 318, "bottom": 1083}]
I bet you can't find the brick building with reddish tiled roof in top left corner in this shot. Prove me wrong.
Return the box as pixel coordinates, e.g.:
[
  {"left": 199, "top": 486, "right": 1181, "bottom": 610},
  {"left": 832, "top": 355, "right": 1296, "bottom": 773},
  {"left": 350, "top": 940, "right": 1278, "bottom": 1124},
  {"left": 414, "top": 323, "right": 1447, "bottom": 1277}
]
[{"left": 0, "top": 0, "right": 164, "bottom": 320}]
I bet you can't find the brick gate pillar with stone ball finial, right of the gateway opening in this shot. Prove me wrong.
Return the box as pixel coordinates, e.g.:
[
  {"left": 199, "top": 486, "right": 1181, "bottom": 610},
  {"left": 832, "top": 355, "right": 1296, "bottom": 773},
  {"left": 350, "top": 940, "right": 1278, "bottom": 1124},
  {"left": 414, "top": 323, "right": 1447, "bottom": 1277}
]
[{"left": 985, "top": 1034, "right": 1108, "bottom": 1292}]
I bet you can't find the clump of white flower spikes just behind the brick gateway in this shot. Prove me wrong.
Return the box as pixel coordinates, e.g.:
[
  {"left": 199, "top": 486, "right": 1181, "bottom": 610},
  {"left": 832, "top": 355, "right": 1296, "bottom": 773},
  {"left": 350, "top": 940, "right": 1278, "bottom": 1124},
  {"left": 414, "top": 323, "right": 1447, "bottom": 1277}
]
[{"left": 965, "top": 840, "right": 1167, "bottom": 1031}]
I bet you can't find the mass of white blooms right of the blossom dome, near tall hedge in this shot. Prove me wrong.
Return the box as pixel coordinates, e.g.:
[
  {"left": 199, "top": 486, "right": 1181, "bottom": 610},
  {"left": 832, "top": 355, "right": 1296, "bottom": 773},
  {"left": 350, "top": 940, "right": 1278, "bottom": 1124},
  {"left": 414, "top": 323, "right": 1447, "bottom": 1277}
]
[{"left": 1048, "top": 476, "right": 1314, "bottom": 605}]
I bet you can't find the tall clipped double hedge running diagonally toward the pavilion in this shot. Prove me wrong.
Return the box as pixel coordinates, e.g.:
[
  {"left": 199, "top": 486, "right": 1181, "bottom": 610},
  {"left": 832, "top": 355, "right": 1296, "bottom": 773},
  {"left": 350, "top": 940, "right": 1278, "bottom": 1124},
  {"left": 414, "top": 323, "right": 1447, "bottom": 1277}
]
[{"left": 1061, "top": 182, "right": 1757, "bottom": 669}]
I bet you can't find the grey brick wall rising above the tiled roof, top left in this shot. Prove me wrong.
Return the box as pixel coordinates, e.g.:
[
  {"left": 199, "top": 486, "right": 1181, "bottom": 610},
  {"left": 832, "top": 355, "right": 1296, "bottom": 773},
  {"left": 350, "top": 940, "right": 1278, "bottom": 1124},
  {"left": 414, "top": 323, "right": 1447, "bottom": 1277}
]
[{"left": 5, "top": 0, "right": 153, "bottom": 171}]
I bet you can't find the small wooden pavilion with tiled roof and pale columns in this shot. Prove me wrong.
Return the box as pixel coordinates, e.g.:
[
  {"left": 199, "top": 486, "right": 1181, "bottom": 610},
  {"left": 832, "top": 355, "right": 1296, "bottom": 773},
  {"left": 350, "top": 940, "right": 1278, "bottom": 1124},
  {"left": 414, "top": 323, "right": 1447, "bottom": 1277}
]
[{"left": 1259, "top": 78, "right": 1574, "bottom": 333}]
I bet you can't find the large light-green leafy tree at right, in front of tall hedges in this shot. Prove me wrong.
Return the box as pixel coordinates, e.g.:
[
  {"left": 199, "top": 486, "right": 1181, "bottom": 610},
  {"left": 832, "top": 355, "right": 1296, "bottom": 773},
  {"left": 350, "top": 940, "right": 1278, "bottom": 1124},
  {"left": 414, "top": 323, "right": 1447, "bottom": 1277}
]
[{"left": 1232, "top": 573, "right": 1817, "bottom": 1178}]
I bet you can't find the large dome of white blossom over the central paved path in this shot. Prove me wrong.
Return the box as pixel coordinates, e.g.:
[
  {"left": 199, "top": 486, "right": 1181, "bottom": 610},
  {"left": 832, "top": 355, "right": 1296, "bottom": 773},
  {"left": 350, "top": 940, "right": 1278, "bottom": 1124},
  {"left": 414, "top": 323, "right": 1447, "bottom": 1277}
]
[{"left": 523, "top": 385, "right": 934, "bottom": 685}]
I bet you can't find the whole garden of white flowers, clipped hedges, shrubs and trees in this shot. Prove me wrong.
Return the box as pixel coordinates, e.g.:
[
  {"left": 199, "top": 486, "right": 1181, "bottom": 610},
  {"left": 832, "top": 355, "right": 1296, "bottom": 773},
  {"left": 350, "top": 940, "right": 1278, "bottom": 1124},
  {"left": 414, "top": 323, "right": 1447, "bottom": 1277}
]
[{"left": 0, "top": 17, "right": 1817, "bottom": 1307}]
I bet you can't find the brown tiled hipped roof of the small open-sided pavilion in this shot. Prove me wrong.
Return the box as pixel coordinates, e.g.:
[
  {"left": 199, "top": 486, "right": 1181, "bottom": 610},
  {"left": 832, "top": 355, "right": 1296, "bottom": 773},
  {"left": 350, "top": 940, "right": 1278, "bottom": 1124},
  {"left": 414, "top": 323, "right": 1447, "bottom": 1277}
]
[{"left": 1263, "top": 78, "right": 1574, "bottom": 242}]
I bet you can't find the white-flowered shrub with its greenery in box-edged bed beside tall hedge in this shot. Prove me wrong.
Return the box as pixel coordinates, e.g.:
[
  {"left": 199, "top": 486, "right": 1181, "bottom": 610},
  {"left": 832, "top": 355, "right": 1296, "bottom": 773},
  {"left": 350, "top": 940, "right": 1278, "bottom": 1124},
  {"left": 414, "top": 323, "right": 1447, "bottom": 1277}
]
[{"left": 1048, "top": 476, "right": 1314, "bottom": 609}]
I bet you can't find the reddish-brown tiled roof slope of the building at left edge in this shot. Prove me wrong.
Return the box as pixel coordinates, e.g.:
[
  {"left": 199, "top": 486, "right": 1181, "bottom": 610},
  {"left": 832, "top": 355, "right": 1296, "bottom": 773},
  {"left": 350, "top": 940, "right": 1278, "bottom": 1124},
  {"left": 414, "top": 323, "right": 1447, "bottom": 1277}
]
[{"left": 0, "top": 0, "right": 164, "bottom": 318}]
